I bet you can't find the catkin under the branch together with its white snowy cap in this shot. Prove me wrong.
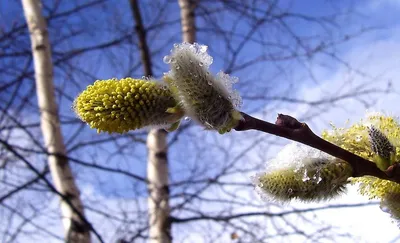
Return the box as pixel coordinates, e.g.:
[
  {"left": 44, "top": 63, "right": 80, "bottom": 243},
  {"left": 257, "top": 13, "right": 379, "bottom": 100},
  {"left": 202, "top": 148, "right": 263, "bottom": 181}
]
[{"left": 252, "top": 143, "right": 352, "bottom": 202}]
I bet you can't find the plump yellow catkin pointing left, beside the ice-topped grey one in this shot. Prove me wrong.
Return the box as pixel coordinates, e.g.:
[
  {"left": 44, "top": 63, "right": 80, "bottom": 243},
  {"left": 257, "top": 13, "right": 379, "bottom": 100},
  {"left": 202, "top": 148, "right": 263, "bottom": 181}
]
[{"left": 73, "top": 78, "right": 183, "bottom": 133}]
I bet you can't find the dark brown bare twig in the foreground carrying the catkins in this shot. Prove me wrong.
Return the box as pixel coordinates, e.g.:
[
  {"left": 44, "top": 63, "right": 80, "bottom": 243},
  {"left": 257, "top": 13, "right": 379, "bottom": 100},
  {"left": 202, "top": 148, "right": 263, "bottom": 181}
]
[{"left": 235, "top": 113, "right": 400, "bottom": 183}]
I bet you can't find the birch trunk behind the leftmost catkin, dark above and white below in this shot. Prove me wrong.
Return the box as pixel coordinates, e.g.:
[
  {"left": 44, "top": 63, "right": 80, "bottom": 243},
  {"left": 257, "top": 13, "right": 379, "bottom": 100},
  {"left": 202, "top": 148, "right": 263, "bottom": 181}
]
[{"left": 130, "top": 0, "right": 172, "bottom": 243}]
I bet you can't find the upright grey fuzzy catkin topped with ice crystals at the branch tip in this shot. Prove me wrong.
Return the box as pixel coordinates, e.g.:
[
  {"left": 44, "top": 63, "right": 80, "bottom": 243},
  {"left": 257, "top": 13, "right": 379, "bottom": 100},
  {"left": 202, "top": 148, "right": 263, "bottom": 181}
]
[{"left": 164, "top": 43, "right": 241, "bottom": 133}]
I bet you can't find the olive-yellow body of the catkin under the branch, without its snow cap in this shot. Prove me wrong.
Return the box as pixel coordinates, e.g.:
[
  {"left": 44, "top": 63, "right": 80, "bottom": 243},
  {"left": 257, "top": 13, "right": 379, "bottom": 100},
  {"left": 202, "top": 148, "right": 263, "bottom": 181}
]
[{"left": 257, "top": 158, "right": 352, "bottom": 201}]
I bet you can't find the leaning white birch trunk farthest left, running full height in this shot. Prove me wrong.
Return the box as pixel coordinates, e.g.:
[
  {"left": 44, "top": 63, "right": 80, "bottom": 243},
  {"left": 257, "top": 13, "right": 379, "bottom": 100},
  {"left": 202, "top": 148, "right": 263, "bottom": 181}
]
[{"left": 22, "top": 0, "right": 90, "bottom": 243}]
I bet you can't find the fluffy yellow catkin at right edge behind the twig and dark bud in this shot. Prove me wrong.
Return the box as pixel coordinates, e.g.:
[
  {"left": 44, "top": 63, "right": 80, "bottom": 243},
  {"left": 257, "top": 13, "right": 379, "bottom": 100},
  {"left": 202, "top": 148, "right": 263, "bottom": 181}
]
[{"left": 323, "top": 114, "right": 400, "bottom": 225}]
